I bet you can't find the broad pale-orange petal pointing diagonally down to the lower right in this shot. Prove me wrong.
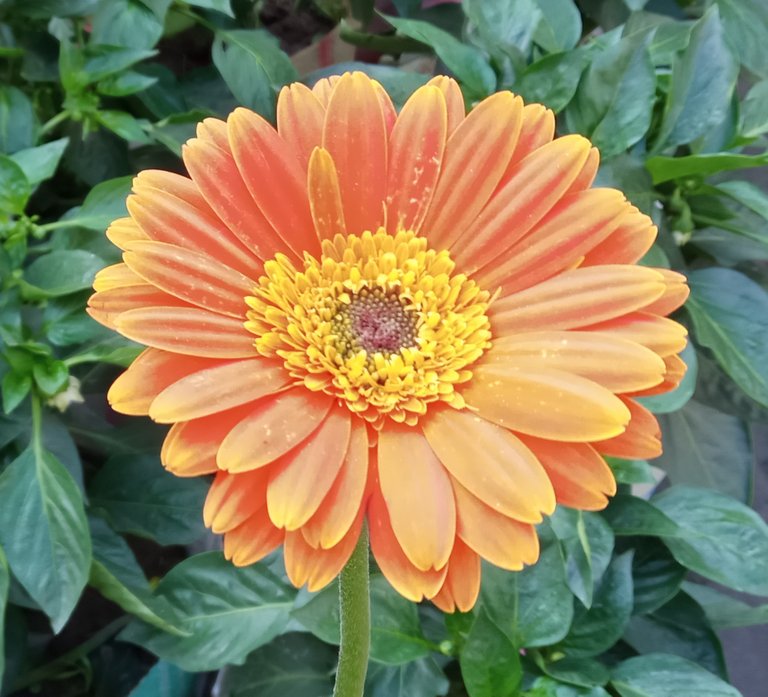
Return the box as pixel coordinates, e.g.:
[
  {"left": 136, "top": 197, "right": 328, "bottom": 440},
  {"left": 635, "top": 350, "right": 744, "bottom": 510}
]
[{"left": 423, "top": 409, "right": 555, "bottom": 523}]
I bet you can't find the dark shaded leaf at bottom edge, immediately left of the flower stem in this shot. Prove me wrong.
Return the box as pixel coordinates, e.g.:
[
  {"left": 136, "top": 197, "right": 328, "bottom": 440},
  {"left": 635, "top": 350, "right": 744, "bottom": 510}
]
[{"left": 218, "top": 633, "right": 337, "bottom": 697}]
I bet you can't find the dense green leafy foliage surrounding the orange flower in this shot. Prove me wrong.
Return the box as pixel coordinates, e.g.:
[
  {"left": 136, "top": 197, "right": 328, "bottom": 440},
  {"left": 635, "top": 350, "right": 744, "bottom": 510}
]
[{"left": 0, "top": 0, "right": 768, "bottom": 697}]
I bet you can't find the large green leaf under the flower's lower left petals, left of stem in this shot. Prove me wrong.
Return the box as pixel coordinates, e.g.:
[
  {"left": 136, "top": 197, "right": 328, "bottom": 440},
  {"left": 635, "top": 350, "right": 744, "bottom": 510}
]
[{"left": 120, "top": 552, "right": 295, "bottom": 672}]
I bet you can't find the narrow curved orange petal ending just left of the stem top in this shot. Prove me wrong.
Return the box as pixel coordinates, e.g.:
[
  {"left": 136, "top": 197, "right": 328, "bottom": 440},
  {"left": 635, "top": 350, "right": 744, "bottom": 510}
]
[{"left": 301, "top": 419, "right": 369, "bottom": 549}]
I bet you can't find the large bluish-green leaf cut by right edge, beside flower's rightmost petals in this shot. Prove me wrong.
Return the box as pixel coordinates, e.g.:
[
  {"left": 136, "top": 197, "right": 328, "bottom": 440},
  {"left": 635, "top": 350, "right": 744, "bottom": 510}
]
[{"left": 686, "top": 268, "right": 768, "bottom": 405}]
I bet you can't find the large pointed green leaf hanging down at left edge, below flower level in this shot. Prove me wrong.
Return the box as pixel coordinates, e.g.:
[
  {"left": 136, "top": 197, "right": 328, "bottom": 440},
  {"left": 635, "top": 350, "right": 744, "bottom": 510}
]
[{"left": 0, "top": 448, "right": 91, "bottom": 632}]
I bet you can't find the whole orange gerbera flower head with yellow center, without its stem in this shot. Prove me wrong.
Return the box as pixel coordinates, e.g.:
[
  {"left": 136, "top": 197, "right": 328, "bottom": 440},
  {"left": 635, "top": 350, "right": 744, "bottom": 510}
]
[{"left": 90, "top": 73, "right": 687, "bottom": 611}]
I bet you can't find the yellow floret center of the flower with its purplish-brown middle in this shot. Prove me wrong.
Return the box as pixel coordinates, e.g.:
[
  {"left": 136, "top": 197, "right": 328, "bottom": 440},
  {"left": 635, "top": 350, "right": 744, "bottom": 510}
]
[{"left": 245, "top": 229, "right": 491, "bottom": 427}]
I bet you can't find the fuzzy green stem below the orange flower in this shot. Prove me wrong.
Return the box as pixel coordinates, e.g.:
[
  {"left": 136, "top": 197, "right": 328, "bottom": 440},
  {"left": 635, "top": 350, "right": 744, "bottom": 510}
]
[{"left": 333, "top": 525, "right": 371, "bottom": 697}]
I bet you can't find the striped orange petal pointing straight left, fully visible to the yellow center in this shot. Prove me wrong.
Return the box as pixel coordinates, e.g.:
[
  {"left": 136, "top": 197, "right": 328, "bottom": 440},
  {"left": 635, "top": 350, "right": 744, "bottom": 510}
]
[{"left": 117, "top": 307, "right": 256, "bottom": 358}]
